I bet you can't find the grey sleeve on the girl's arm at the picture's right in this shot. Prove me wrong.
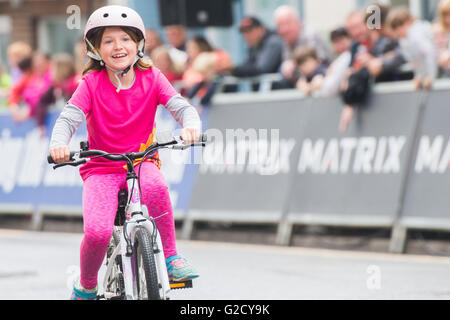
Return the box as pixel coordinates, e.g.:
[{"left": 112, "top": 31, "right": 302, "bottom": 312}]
[{"left": 164, "top": 94, "right": 202, "bottom": 131}]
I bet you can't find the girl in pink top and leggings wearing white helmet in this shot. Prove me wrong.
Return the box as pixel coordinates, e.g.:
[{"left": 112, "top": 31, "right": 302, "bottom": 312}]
[{"left": 50, "top": 6, "right": 201, "bottom": 299}]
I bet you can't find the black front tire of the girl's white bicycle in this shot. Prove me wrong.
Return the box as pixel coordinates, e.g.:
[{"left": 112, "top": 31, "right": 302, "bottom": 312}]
[{"left": 133, "top": 227, "right": 161, "bottom": 300}]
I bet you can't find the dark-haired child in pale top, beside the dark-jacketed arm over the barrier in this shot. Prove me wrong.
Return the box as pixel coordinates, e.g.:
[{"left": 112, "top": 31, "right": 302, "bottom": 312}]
[{"left": 320, "top": 27, "right": 352, "bottom": 96}]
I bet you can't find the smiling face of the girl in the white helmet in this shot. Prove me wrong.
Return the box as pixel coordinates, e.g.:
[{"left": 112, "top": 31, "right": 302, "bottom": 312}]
[{"left": 99, "top": 27, "right": 137, "bottom": 70}]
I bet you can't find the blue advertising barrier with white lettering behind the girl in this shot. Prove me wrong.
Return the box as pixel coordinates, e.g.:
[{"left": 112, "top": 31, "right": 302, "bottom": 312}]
[{"left": 0, "top": 105, "right": 207, "bottom": 230}]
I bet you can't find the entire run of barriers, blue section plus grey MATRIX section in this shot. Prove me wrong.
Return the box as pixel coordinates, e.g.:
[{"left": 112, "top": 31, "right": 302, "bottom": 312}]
[{"left": 0, "top": 80, "right": 450, "bottom": 252}]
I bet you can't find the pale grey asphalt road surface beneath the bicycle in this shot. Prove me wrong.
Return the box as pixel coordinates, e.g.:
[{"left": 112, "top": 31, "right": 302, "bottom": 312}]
[{"left": 0, "top": 229, "right": 450, "bottom": 300}]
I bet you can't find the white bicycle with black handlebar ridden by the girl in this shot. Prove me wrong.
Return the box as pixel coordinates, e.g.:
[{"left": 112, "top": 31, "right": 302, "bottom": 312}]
[{"left": 48, "top": 135, "right": 207, "bottom": 300}]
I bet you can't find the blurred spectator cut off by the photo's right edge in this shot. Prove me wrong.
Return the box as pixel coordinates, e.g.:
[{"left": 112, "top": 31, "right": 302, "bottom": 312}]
[{"left": 433, "top": 0, "right": 450, "bottom": 77}]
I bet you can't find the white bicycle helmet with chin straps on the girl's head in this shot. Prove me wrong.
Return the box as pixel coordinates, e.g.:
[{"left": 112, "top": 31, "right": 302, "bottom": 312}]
[{"left": 84, "top": 5, "right": 145, "bottom": 92}]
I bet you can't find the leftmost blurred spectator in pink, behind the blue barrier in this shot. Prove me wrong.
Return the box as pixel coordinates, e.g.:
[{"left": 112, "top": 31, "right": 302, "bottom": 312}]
[{"left": 8, "top": 53, "right": 52, "bottom": 122}]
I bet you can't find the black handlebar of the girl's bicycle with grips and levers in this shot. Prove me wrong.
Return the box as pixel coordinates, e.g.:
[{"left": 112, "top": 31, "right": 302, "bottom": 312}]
[{"left": 47, "top": 134, "right": 208, "bottom": 169}]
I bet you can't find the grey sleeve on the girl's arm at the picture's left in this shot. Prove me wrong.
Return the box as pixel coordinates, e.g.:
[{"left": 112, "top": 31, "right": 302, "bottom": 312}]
[{"left": 50, "top": 104, "right": 86, "bottom": 149}]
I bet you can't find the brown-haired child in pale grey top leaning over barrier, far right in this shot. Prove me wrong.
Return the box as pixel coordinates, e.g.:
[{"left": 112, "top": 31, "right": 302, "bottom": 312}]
[{"left": 387, "top": 7, "right": 438, "bottom": 90}]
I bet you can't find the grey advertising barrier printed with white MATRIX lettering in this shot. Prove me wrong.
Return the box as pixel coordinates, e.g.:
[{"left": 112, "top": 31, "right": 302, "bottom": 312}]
[{"left": 182, "top": 80, "right": 450, "bottom": 252}]
